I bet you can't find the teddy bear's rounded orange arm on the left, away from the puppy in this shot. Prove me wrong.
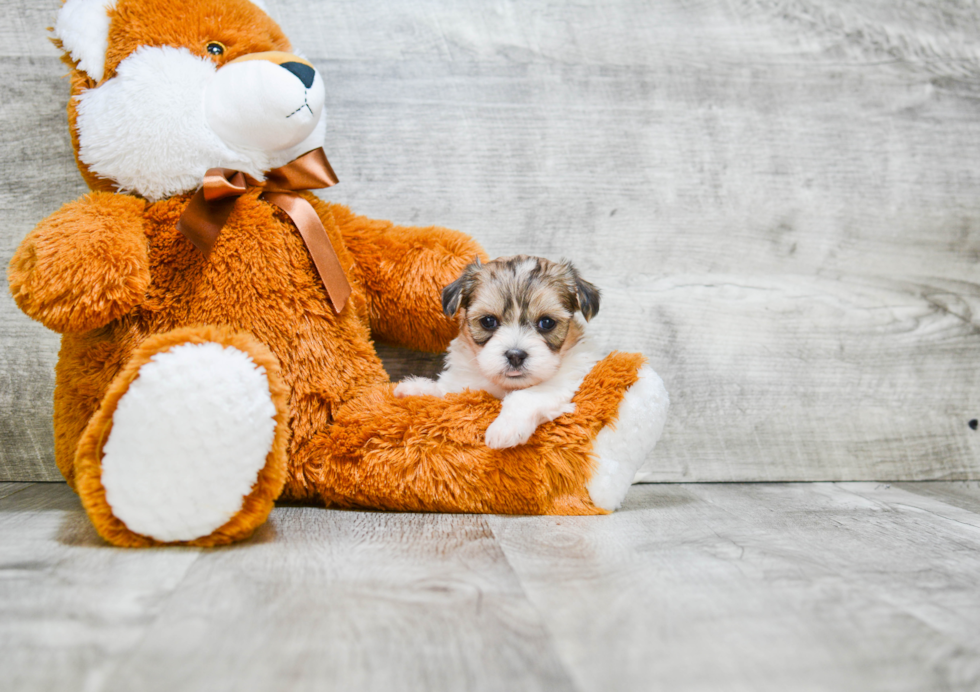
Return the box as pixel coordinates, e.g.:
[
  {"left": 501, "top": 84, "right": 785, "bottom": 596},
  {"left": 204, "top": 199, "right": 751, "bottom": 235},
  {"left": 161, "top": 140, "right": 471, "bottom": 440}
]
[{"left": 7, "top": 192, "right": 150, "bottom": 333}]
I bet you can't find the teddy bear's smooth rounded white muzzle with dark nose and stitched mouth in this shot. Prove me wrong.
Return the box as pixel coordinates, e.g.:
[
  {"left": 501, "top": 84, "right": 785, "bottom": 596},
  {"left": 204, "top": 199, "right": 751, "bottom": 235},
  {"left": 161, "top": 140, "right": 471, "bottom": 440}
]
[{"left": 205, "top": 51, "right": 325, "bottom": 152}]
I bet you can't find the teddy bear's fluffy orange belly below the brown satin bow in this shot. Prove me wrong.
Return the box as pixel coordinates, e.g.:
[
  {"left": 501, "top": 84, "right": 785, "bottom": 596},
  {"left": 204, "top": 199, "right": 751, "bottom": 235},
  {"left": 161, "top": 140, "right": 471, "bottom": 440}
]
[{"left": 138, "top": 196, "right": 388, "bottom": 402}]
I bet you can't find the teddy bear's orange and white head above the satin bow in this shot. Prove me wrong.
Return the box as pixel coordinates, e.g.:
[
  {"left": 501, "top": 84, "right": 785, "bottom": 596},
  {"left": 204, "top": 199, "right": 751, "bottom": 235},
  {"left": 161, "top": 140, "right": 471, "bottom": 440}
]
[{"left": 52, "top": 0, "right": 325, "bottom": 200}]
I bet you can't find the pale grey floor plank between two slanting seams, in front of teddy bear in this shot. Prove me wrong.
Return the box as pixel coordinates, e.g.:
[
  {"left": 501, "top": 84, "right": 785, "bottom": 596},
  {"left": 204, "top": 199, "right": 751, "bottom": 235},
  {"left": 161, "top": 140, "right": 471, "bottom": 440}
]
[{"left": 97, "top": 507, "right": 574, "bottom": 692}]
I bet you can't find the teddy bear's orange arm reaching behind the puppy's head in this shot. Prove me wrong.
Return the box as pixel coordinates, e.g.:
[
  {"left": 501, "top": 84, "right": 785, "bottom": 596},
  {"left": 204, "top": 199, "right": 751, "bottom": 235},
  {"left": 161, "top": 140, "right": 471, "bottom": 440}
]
[{"left": 332, "top": 200, "right": 487, "bottom": 352}]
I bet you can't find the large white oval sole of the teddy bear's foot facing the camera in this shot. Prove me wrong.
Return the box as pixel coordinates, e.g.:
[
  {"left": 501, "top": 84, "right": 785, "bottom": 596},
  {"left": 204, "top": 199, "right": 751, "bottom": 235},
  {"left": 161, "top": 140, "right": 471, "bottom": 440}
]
[{"left": 102, "top": 343, "right": 276, "bottom": 541}]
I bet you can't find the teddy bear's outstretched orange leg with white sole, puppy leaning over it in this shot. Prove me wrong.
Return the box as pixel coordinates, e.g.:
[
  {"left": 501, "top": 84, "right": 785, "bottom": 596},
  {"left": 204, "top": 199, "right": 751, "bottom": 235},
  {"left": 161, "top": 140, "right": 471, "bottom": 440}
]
[{"left": 318, "top": 353, "right": 668, "bottom": 514}]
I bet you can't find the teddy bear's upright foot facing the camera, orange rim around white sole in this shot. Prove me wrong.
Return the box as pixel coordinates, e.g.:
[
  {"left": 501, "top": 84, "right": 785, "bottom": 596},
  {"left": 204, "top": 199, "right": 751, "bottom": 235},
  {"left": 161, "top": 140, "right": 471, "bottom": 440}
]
[{"left": 75, "top": 327, "right": 288, "bottom": 546}]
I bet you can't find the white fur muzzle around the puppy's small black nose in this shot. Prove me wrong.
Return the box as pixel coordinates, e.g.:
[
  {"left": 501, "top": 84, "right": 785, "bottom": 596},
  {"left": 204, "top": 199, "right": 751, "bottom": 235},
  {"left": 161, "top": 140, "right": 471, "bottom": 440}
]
[{"left": 476, "top": 325, "right": 561, "bottom": 389}]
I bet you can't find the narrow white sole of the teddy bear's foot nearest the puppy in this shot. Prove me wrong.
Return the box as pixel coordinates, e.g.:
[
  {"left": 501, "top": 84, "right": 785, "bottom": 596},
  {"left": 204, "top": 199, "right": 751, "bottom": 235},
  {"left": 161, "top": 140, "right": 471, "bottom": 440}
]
[{"left": 587, "top": 366, "right": 670, "bottom": 512}]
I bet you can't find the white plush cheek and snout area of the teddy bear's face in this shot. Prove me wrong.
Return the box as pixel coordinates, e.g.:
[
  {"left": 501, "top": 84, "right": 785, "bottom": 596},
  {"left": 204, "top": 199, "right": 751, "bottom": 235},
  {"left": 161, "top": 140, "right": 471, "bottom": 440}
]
[{"left": 76, "top": 46, "right": 326, "bottom": 201}]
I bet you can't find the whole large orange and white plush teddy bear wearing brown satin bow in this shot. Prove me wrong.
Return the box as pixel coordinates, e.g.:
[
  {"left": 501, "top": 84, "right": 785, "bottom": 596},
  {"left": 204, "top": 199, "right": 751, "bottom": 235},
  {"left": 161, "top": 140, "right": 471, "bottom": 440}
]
[{"left": 8, "top": 0, "right": 668, "bottom": 546}]
